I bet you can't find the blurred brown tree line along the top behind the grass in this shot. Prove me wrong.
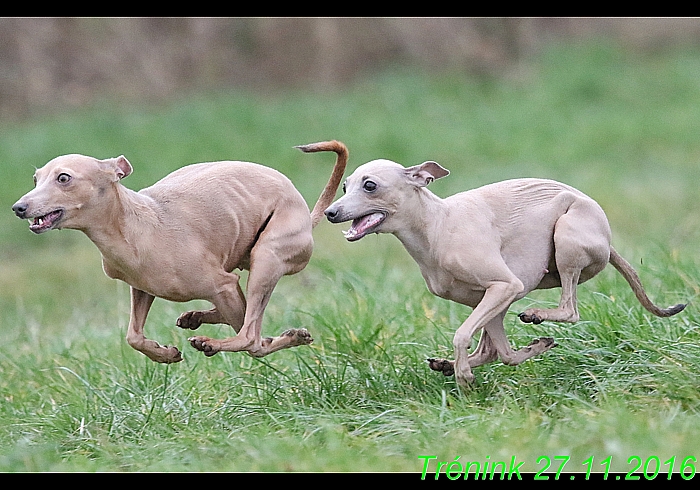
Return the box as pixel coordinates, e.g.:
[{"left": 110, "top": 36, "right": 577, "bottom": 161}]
[{"left": 0, "top": 17, "right": 700, "bottom": 118}]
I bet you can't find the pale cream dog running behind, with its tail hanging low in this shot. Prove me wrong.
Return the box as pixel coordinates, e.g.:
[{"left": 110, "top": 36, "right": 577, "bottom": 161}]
[{"left": 325, "top": 160, "right": 685, "bottom": 386}]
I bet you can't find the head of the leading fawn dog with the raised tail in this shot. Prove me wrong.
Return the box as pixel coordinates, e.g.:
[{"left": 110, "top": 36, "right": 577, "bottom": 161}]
[{"left": 12, "top": 154, "right": 132, "bottom": 233}]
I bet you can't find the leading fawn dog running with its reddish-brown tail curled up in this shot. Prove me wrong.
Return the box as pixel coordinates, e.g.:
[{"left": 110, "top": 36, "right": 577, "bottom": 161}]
[{"left": 12, "top": 141, "right": 348, "bottom": 363}]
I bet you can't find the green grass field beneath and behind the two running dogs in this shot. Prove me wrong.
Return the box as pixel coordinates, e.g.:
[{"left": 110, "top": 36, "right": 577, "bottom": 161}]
[{"left": 0, "top": 43, "right": 700, "bottom": 478}]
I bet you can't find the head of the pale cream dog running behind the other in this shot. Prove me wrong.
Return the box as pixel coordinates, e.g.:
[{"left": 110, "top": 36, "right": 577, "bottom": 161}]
[{"left": 325, "top": 160, "right": 450, "bottom": 242}]
